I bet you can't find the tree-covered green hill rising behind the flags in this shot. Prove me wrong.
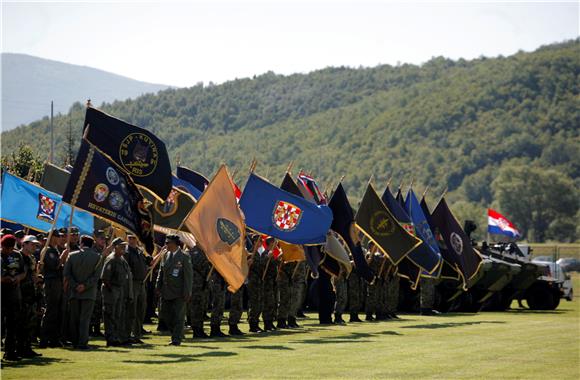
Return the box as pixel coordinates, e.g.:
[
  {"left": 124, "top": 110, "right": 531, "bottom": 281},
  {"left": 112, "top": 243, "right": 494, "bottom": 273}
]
[{"left": 2, "top": 39, "right": 580, "bottom": 241}]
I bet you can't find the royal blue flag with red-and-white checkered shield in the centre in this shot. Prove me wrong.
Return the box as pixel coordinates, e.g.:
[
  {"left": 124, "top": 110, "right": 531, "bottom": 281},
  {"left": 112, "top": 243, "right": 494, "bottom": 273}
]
[{"left": 240, "top": 173, "right": 332, "bottom": 244}]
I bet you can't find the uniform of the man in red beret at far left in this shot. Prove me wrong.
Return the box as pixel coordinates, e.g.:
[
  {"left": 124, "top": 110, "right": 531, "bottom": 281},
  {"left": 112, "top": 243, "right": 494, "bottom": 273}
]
[{"left": 1, "top": 250, "right": 26, "bottom": 360}]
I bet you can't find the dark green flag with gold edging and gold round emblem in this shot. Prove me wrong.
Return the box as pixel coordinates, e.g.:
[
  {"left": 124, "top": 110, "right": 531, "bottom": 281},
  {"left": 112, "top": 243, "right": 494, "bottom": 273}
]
[{"left": 355, "top": 183, "right": 422, "bottom": 265}]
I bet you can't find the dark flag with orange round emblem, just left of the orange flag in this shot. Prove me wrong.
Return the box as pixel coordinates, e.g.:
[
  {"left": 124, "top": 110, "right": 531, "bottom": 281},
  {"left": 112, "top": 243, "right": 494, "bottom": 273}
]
[{"left": 145, "top": 177, "right": 195, "bottom": 230}]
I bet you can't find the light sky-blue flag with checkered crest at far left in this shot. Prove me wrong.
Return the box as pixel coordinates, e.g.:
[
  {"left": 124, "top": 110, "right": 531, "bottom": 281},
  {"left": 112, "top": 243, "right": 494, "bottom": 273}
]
[{"left": 2, "top": 172, "right": 95, "bottom": 234}]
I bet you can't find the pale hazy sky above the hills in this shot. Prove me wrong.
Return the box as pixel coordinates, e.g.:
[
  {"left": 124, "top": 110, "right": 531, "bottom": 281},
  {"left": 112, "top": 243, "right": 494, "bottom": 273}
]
[{"left": 2, "top": 0, "right": 580, "bottom": 86}]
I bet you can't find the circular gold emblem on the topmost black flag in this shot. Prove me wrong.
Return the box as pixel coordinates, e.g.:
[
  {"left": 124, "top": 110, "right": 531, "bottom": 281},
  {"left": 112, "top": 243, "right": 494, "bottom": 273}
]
[{"left": 119, "top": 133, "right": 159, "bottom": 177}]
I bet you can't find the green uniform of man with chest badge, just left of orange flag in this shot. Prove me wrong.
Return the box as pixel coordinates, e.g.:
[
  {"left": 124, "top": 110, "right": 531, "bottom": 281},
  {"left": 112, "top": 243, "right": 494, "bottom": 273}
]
[{"left": 157, "top": 248, "right": 193, "bottom": 345}]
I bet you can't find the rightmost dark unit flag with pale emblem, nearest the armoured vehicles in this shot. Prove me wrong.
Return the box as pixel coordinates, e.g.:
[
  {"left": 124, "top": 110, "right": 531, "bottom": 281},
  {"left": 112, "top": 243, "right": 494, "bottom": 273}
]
[{"left": 431, "top": 198, "right": 482, "bottom": 284}]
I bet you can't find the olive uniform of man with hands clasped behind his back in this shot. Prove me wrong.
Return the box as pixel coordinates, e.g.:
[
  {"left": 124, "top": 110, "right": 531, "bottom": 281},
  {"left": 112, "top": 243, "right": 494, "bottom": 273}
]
[{"left": 64, "top": 248, "right": 102, "bottom": 348}]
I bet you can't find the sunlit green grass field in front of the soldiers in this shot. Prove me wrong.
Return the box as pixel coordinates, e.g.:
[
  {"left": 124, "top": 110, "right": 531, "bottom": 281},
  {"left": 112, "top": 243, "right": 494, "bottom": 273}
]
[{"left": 1, "top": 274, "right": 580, "bottom": 379}]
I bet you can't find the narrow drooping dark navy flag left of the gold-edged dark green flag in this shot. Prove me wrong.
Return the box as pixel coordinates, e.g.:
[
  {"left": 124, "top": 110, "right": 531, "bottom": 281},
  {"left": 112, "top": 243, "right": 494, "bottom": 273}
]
[{"left": 328, "top": 183, "right": 374, "bottom": 282}]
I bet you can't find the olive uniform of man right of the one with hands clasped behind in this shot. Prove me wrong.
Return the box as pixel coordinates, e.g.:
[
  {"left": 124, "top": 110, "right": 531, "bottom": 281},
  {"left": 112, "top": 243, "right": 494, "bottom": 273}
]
[{"left": 101, "top": 252, "right": 131, "bottom": 346}]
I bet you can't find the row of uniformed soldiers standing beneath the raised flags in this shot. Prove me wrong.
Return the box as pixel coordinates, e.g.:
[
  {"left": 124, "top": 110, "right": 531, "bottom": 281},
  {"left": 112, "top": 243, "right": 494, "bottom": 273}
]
[{"left": 2, "top": 227, "right": 431, "bottom": 360}]
